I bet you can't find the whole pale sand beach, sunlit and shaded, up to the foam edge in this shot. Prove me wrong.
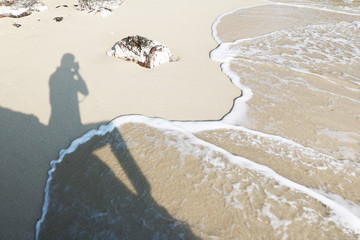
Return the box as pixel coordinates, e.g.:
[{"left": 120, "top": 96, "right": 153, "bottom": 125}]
[{"left": 0, "top": 0, "right": 262, "bottom": 239}]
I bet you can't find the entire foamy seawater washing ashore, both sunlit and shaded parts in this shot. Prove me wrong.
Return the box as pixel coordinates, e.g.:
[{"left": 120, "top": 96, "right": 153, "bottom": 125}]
[{"left": 36, "top": 0, "right": 360, "bottom": 239}]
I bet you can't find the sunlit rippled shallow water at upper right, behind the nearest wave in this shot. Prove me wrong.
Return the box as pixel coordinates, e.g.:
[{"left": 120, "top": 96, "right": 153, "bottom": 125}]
[{"left": 212, "top": 1, "right": 360, "bottom": 162}]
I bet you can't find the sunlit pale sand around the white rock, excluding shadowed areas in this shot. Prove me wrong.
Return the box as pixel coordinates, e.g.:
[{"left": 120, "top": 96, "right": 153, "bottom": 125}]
[{"left": 0, "top": 0, "right": 259, "bottom": 124}]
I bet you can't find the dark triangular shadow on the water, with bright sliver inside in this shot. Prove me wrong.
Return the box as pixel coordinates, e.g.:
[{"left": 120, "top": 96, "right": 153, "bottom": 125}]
[{"left": 38, "top": 129, "right": 199, "bottom": 239}]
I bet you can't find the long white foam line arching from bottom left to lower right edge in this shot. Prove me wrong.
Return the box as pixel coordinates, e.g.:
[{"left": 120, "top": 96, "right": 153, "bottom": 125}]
[{"left": 36, "top": 115, "right": 360, "bottom": 239}]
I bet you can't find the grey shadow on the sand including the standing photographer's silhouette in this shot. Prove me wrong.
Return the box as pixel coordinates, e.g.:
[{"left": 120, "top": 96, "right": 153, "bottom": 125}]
[{"left": 0, "top": 53, "right": 102, "bottom": 240}]
